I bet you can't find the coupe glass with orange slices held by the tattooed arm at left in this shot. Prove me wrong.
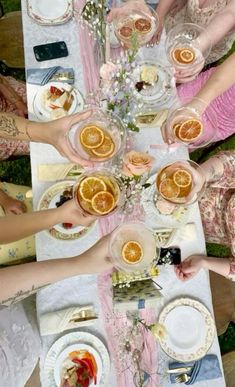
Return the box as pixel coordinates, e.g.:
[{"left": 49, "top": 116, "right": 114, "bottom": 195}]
[{"left": 69, "top": 106, "right": 126, "bottom": 163}]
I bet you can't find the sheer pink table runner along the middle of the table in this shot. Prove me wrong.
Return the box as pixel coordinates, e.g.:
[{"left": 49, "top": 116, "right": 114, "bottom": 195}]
[{"left": 75, "top": 6, "right": 160, "bottom": 387}]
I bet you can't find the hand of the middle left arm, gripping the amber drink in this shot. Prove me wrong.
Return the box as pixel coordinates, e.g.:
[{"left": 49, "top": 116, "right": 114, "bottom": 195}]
[{"left": 56, "top": 199, "right": 96, "bottom": 227}]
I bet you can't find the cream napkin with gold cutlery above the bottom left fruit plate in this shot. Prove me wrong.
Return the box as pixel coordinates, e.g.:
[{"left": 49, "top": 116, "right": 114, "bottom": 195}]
[{"left": 39, "top": 305, "right": 97, "bottom": 336}]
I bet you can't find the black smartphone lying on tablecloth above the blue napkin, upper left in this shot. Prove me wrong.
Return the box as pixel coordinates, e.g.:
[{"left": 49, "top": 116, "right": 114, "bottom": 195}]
[{"left": 33, "top": 42, "right": 69, "bottom": 62}]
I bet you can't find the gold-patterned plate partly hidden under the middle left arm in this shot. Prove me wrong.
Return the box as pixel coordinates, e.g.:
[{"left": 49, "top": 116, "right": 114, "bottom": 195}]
[{"left": 37, "top": 180, "right": 96, "bottom": 240}]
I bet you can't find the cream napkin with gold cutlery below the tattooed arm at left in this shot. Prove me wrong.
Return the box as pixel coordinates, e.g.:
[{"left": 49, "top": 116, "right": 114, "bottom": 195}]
[{"left": 38, "top": 163, "right": 83, "bottom": 181}]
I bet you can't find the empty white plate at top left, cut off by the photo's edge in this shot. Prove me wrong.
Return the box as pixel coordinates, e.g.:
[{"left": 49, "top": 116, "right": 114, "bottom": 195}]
[{"left": 27, "top": 0, "right": 73, "bottom": 25}]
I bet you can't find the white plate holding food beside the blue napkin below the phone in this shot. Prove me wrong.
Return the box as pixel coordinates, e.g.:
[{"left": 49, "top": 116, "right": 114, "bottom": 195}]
[{"left": 33, "top": 82, "right": 84, "bottom": 121}]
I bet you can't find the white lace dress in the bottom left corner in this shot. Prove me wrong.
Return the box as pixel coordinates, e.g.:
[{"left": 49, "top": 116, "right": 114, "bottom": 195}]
[{"left": 0, "top": 298, "right": 41, "bottom": 387}]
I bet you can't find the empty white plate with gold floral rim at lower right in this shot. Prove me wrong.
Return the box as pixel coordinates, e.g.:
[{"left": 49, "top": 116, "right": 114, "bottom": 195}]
[{"left": 159, "top": 298, "right": 215, "bottom": 362}]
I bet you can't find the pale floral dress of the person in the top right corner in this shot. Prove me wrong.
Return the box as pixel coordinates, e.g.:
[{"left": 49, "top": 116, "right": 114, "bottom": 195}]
[{"left": 165, "top": 0, "right": 235, "bottom": 63}]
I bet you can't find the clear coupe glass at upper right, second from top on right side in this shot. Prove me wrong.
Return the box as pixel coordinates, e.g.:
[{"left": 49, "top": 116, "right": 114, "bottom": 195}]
[{"left": 165, "top": 23, "right": 211, "bottom": 75}]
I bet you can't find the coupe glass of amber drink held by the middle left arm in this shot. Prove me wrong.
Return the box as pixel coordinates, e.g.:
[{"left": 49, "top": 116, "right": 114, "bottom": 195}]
[{"left": 73, "top": 169, "right": 124, "bottom": 218}]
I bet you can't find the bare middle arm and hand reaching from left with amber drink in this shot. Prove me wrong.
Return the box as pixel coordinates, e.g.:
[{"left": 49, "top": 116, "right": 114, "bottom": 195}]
[{"left": 0, "top": 199, "right": 95, "bottom": 244}]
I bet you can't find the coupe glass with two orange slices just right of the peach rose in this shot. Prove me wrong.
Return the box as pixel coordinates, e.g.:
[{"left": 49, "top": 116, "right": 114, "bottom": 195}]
[{"left": 156, "top": 160, "right": 206, "bottom": 206}]
